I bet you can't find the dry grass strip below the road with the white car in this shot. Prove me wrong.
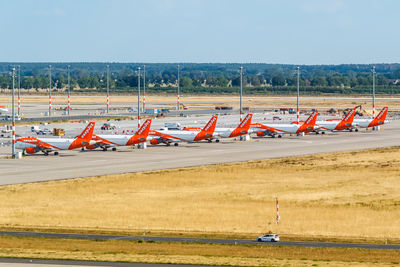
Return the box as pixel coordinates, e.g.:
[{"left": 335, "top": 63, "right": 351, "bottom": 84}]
[{"left": 0, "top": 237, "right": 399, "bottom": 266}]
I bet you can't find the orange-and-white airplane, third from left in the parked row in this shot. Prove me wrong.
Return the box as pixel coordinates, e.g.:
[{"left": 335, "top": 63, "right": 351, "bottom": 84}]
[{"left": 149, "top": 115, "right": 218, "bottom": 146}]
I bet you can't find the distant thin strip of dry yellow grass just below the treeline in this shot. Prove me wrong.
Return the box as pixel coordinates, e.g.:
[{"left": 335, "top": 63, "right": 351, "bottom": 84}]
[{"left": 0, "top": 94, "right": 400, "bottom": 109}]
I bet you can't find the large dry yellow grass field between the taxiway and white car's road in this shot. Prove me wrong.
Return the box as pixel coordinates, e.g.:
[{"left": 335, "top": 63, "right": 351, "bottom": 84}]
[{"left": 0, "top": 147, "right": 400, "bottom": 242}]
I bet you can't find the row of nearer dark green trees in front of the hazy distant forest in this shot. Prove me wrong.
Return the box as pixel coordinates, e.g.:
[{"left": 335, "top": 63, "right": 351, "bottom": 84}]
[{"left": 0, "top": 74, "right": 400, "bottom": 89}]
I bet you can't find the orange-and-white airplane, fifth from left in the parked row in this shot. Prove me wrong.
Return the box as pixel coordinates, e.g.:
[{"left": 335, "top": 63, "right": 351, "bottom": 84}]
[{"left": 251, "top": 110, "right": 318, "bottom": 138}]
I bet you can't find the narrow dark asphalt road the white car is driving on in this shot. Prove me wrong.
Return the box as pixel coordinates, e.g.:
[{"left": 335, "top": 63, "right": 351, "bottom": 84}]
[{"left": 0, "top": 231, "right": 400, "bottom": 252}]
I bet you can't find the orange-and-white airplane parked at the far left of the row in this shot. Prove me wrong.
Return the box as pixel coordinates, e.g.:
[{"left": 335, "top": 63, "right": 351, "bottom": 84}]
[{"left": 15, "top": 122, "right": 96, "bottom": 156}]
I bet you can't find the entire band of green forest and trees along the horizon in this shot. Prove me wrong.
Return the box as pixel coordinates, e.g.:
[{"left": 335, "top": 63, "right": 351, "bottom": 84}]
[{"left": 0, "top": 62, "right": 400, "bottom": 94}]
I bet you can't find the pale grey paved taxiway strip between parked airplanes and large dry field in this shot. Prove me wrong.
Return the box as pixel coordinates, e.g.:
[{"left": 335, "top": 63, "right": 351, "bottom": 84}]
[{"left": 0, "top": 118, "right": 400, "bottom": 185}]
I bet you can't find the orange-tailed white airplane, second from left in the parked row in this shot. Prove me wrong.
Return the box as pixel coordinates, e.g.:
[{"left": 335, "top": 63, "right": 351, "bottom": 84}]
[{"left": 86, "top": 119, "right": 151, "bottom": 151}]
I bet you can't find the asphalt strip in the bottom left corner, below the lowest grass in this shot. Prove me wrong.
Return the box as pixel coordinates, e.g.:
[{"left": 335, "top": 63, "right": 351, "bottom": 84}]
[{"left": 0, "top": 258, "right": 216, "bottom": 267}]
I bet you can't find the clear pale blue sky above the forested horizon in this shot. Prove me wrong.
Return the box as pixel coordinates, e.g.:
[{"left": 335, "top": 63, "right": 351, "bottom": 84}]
[{"left": 0, "top": 0, "right": 400, "bottom": 64}]
